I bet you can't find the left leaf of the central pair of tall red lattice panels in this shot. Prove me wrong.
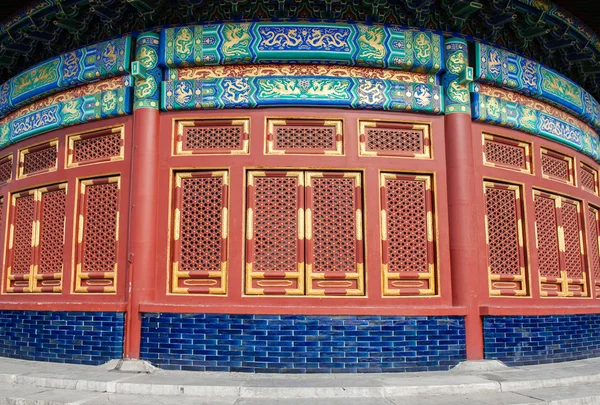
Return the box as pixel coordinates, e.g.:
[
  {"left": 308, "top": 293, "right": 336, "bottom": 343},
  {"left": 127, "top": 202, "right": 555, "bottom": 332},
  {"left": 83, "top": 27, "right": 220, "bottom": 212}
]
[{"left": 246, "top": 172, "right": 304, "bottom": 295}]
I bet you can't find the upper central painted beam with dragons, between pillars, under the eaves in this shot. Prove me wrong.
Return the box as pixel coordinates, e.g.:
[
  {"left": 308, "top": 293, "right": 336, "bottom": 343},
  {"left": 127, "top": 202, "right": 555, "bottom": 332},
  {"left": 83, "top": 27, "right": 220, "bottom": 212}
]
[{"left": 160, "top": 22, "right": 443, "bottom": 73}]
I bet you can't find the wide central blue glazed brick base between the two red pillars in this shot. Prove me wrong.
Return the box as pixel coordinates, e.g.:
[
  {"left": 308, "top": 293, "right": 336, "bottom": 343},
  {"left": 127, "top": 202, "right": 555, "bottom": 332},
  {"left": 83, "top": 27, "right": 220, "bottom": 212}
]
[{"left": 141, "top": 313, "right": 465, "bottom": 373}]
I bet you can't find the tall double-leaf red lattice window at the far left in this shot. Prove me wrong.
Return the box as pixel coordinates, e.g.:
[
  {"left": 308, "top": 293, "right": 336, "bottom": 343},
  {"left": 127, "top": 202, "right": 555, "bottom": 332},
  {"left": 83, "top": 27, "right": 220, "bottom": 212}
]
[{"left": 6, "top": 184, "right": 67, "bottom": 293}]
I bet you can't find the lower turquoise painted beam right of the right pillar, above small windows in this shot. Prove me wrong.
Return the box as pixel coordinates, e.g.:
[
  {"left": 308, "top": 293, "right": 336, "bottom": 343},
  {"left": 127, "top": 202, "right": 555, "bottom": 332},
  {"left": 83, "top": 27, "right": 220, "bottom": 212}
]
[{"left": 471, "top": 85, "right": 600, "bottom": 160}]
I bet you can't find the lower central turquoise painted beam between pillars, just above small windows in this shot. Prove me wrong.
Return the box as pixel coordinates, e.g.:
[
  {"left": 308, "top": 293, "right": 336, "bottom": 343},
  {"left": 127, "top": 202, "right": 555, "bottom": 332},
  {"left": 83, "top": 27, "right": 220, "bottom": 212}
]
[{"left": 161, "top": 76, "right": 444, "bottom": 114}]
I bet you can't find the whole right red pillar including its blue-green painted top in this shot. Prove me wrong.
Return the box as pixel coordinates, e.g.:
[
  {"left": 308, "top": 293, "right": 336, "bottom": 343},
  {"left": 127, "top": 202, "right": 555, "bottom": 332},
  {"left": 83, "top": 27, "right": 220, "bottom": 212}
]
[{"left": 443, "top": 38, "right": 487, "bottom": 360}]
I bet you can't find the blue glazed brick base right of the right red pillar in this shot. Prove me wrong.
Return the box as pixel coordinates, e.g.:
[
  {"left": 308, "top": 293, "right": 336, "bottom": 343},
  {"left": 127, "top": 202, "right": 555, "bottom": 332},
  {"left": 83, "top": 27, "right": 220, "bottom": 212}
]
[{"left": 483, "top": 314, "right": 600, "bottom": 366}]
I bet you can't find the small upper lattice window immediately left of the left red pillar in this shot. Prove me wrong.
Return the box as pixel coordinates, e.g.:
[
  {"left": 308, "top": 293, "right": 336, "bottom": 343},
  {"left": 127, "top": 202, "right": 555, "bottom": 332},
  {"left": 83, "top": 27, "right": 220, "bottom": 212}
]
[{"left": 67, "top": 127, "right": 125, "bottom": 167}]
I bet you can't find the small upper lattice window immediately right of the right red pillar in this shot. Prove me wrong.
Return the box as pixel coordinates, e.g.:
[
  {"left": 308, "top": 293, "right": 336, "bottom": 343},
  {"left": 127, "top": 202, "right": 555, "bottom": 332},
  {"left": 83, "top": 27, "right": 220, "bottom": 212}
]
[{"left": 483, "top": 134, "right": 531, "bottom": 173}]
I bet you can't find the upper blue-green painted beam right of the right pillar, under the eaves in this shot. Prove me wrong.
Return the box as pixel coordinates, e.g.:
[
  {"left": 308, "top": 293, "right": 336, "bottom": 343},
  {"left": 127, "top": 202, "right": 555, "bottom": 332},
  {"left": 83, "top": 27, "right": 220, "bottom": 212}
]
[{"left": 475, "top": 43, "right": 600, "bottom": 130}]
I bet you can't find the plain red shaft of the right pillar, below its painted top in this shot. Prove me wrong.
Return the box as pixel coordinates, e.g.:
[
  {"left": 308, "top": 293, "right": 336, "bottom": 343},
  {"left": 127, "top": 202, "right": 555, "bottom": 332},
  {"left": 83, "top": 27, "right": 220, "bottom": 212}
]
[{"left": 445, "top": 113, "right": 486, "bottom": 360}]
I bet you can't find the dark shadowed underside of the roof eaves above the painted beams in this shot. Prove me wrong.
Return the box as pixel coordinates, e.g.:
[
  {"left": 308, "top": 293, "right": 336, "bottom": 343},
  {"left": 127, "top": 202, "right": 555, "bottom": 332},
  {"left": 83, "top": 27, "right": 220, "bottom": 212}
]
[{"left": 0, "top": 0, "right": 600, "bottom": 99}]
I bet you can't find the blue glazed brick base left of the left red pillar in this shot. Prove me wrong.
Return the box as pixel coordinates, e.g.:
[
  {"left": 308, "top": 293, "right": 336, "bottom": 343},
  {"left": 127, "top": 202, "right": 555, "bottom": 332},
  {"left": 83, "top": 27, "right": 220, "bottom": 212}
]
[{"left": 0, "top": 311, "right": 125, "bottom": 365}]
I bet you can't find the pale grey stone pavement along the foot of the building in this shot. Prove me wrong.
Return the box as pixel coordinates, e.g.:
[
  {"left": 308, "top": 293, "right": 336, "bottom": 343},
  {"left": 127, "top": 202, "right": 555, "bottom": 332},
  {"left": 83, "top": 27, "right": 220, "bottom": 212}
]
[{"left": 0, "top": 357, "right": 600, "bottom": 405}]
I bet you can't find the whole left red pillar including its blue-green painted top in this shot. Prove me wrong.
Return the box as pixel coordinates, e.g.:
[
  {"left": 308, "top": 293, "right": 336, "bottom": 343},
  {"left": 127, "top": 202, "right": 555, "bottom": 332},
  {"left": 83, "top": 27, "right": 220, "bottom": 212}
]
[{"left": 123, "top": 33, "right": 162, "bottom": 359}]
